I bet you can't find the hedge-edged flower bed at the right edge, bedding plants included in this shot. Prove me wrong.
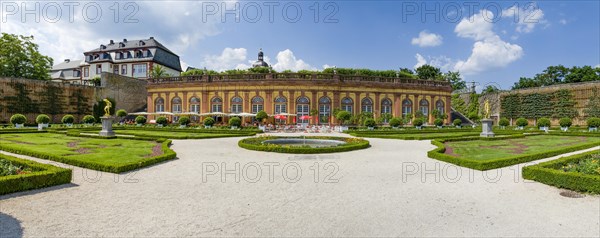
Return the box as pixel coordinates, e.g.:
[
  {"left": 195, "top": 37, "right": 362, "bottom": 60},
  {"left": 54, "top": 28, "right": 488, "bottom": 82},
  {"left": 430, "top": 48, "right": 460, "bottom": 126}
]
[{"left": 523, "top": 151, "right": 600, "bottom": 194}]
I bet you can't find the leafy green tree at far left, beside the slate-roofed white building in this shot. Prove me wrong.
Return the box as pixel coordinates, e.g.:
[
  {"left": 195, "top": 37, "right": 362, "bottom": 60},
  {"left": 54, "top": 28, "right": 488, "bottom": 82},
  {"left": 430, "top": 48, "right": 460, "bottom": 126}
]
[{"left": 0, "top": 32, "right": 53, "bottom": 80}]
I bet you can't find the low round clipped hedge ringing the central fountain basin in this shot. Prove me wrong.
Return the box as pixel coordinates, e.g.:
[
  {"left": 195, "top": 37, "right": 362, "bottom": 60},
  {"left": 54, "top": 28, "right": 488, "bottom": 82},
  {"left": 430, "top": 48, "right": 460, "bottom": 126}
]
[{"left": 238, "top": 136, "right": 371, "bottom": 154}]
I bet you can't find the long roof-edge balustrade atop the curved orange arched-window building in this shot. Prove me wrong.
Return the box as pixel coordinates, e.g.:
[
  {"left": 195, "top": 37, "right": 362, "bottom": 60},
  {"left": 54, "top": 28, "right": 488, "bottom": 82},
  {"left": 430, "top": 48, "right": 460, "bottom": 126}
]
[{"left": 148, "top": 73, "right": 450, "bottom": 87}]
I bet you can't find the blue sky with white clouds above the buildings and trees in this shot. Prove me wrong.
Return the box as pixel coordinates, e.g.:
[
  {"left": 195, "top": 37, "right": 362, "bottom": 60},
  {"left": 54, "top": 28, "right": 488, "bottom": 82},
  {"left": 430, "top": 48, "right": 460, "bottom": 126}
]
[{"left": 0, "top": 1, "right": 600, "bottom": 89}]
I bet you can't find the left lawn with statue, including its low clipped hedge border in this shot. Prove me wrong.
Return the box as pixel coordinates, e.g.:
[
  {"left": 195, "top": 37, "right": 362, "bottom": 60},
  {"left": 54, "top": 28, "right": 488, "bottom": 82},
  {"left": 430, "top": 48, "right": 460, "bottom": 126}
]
[{"left": 0, "top": 133, "right": 175, "bottom": 172}]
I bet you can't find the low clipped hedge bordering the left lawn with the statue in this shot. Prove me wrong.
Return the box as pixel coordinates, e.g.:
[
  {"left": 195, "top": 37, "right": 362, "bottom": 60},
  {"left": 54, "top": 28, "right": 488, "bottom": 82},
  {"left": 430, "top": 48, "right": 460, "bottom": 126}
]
[{"left": 0, "top": 136, "right": 177, "bottom": 173}]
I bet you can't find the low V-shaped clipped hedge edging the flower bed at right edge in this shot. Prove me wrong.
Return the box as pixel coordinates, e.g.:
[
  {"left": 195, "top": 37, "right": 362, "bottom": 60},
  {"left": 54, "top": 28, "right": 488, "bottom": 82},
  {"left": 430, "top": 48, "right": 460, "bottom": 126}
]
[{"left": 523, "top": 151, "right": 600, "bottom": 194}]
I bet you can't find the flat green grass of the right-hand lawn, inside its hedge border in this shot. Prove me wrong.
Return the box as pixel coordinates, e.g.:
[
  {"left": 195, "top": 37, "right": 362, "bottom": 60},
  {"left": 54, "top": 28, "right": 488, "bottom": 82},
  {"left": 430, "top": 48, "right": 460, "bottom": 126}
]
[{"left": 445, "top": 135, "right": 600, "bottom": 160}]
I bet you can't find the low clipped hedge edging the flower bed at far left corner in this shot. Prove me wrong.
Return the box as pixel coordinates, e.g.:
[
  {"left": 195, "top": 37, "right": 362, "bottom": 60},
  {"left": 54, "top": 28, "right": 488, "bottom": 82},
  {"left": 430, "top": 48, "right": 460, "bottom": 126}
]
[{"left": 0, "top": 154, "right": 72, "bottom": 195}]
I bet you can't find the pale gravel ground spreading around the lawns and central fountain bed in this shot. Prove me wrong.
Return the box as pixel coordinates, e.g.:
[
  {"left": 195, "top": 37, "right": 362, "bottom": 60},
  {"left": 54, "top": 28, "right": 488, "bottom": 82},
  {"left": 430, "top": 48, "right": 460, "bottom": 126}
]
[{"left": 0, "top": 135, "right": 600, "bottom": 238}]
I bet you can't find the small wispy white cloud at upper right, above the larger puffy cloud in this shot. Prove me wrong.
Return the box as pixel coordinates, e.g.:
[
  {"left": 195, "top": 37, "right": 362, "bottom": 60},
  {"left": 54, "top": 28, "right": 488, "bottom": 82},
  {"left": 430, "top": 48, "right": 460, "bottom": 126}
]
[{"left": 502, "top": 5, "right": 549, "bottom": 33}]
